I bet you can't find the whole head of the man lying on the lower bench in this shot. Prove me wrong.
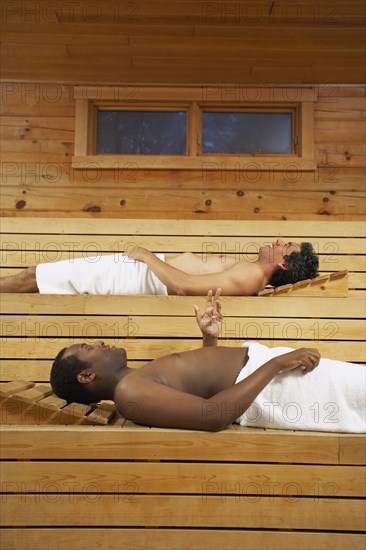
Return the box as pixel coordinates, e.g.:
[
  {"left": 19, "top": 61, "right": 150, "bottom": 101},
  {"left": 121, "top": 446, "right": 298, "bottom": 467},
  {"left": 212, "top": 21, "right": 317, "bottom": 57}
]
[{"left": 50, "top": 342, "right": 126, "bottom": 404}]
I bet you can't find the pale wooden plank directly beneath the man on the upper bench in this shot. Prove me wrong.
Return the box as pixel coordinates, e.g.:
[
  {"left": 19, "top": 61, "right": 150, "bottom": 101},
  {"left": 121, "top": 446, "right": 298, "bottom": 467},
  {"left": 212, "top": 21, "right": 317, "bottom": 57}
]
[{"left": 1, "top": 291, "right": 365, "bottom": 320}]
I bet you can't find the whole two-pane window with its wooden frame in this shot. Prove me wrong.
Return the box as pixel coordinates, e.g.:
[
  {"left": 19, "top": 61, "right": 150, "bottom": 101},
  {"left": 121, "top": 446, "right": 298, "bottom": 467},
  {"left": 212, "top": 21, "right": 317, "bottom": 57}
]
[{"left": 73, "top": 86, "right": 316, "bottom": 170}]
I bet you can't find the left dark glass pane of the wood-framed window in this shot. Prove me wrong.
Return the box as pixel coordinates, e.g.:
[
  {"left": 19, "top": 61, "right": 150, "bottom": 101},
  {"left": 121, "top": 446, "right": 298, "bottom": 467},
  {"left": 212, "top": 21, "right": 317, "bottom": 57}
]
[{"left": 96, "top": 111, "right": 187, "bottom": 155}]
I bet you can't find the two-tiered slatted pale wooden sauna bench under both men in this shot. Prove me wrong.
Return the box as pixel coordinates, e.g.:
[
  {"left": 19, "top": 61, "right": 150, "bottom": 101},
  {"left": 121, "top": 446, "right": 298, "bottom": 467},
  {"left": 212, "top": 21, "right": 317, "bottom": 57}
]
[{"left": 0, "top": 218, "right": 366, "bottom": 550}]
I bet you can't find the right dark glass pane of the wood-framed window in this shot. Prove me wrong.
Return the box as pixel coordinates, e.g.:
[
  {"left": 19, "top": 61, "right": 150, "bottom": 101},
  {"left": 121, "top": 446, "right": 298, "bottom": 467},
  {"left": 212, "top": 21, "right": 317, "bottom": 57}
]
[{"left": 202, "top": 111, "right": 292, "bottom": 154}]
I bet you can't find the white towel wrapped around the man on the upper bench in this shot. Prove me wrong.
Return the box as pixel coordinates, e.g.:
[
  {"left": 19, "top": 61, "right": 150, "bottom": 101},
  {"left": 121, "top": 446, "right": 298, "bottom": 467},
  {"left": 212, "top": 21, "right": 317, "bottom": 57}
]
[{"left": 36, "top": 253, "right": 168, "bottom": 295}]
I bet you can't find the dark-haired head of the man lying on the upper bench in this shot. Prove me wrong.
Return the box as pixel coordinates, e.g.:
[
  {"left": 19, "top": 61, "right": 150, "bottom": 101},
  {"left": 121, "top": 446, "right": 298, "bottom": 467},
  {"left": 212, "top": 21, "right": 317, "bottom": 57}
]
[{"left": 260, "top": 239, "right": 319, "bottom": 287}]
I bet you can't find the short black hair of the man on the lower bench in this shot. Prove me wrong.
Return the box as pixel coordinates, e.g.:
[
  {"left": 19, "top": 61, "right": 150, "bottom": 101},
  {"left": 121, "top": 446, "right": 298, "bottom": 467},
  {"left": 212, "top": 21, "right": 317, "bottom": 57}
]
[{"left": 50, "top": 348, "right": 99, "bottom": 405}]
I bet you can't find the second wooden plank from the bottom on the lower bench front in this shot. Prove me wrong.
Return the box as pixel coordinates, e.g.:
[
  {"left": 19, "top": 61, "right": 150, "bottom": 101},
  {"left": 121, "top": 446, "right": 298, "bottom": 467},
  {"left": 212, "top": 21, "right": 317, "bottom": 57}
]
[{"left": 2, "top": 494, "right": 366, "bottom": 531}]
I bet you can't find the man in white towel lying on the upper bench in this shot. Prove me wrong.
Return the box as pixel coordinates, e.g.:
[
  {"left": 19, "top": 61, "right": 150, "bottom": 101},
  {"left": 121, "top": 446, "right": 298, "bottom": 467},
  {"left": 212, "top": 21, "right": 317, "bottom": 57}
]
[{"left": 0, "top": 239, "right": 318, "bottom": 296}]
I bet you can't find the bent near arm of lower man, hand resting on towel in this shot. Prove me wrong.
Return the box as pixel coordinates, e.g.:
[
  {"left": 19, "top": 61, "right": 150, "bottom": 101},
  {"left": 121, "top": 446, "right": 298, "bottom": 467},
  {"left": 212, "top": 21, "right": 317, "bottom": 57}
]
[{"left": 114, "top": 348, "right": 320, "bottom": 431}]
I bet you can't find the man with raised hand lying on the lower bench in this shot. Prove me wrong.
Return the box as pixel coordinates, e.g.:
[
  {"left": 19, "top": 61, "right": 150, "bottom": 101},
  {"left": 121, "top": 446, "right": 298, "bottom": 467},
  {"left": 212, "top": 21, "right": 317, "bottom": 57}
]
[{"left": 50, "top": 289, "right": 366, "bottom": 433}]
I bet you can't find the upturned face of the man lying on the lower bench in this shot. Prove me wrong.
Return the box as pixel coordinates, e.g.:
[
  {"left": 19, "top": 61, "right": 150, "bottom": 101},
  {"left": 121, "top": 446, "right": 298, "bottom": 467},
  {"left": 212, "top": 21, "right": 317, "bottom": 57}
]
[{"left": 63, "top": 340, "right": 127, "bottom": 374}]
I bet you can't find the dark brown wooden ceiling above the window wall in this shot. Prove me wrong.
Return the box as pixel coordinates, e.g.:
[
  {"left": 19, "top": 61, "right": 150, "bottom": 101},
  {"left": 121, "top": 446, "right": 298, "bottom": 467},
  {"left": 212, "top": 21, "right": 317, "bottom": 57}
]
[{"left": 1, "top": 0, "right": 366, "bottom": 85}]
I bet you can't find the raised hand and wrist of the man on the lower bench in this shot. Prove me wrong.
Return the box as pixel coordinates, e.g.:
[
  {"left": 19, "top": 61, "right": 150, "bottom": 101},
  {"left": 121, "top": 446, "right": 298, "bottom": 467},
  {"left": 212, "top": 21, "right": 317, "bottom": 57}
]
[{"left": 194, "top": 288, "right": 223, "bottom": 347}]
